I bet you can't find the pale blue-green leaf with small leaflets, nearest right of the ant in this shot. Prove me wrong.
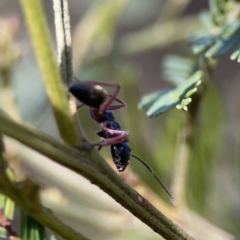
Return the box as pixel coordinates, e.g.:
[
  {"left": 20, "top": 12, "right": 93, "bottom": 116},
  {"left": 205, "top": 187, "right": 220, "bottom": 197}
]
[{"left": 139, "top": 71, "right": 203, "bottom": 117}]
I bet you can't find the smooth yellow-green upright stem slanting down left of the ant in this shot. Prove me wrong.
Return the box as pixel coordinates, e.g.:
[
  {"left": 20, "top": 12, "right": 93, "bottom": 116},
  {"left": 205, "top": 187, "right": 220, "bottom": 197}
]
[{"left": 20, "top": 0, "right": 81, "bottom": 146}]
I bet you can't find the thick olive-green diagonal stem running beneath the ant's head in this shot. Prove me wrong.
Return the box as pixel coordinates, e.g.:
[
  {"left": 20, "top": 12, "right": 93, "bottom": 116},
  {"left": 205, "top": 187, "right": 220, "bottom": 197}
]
[{"left": 0, "top": 113, "right": 192, "bottom": 240}]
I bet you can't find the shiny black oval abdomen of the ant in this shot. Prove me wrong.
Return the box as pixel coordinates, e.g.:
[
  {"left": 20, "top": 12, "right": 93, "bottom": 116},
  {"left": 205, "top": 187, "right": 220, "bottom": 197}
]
[{"left": 69, "top": 81, "right": 107, "bottom": 109}]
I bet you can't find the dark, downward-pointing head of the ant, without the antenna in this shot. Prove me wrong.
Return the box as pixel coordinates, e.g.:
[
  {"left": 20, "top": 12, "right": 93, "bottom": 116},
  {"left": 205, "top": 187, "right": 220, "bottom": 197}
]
[{"left": 111, "top": 143, "right": 131, "bottom": 172}]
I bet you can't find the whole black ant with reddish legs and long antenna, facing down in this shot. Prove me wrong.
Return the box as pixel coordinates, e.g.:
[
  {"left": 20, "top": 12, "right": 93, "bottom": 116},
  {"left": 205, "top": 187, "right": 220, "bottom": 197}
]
[{"left": 69, "top": 79, "right": 176, "bottom": 205}]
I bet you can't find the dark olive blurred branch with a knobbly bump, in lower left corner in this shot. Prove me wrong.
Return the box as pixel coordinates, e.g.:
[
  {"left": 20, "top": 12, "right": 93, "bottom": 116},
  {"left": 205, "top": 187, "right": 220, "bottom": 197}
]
[{"left": 0, "top": 133, "right": 87, "bottom": 240}]
